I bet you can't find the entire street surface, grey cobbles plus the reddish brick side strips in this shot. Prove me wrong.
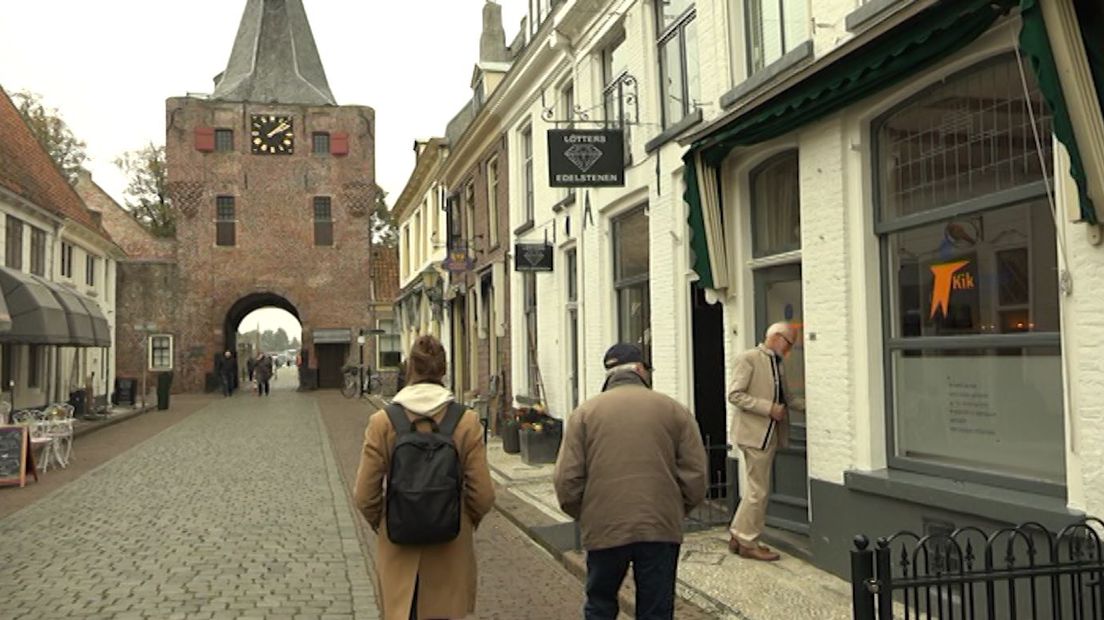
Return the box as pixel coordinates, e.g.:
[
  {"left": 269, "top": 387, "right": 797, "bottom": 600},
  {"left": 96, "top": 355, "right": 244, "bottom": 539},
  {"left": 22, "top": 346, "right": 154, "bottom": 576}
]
[{"left": 0, "top": 373, "right": 631, "bottom": 620}]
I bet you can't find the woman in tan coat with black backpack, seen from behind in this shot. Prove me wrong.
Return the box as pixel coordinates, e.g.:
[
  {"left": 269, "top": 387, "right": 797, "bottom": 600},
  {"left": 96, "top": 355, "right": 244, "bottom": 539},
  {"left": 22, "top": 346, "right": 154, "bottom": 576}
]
[{"left": 354, "top": 335, "right": 495, "bottom": 620}]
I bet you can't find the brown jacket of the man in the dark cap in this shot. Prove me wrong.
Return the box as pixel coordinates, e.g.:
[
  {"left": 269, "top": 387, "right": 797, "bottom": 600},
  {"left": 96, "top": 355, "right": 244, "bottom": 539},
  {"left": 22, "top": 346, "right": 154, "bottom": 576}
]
[{"left": 554, "top": 372, "right": 709, "bottom": 549}]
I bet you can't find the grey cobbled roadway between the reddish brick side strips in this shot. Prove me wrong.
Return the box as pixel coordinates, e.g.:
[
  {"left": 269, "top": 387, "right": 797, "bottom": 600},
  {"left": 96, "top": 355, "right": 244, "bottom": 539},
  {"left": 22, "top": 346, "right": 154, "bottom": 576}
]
[{"left": 0, "top": 377, "right": 379, "bottom": 620}]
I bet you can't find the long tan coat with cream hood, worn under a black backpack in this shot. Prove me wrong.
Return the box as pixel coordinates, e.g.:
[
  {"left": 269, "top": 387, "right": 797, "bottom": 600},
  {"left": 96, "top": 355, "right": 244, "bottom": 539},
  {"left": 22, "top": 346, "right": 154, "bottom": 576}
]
[{"left": 354, "top": 384, "right": 495, "bottom": 620}]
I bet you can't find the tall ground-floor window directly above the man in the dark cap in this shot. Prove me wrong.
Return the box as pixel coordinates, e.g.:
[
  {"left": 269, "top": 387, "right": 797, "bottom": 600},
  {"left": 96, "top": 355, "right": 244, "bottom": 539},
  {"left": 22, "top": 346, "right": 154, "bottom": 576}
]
[{"left": 613, "top": 207, "right": 651, "bottom": 361}]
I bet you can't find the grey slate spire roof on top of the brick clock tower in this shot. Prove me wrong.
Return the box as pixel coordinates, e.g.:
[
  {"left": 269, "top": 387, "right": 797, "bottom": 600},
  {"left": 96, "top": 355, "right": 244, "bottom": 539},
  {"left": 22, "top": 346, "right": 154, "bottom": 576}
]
[{"left": 211, "top": 0, "right": 337, "bottom": 106}]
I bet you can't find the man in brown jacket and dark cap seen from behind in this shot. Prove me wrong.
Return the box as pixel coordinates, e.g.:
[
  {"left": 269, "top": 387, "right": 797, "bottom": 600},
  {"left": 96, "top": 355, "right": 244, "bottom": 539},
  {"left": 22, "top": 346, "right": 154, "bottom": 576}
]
[{"left": 554, "top": 343, "right": 709, "bottom": 620}]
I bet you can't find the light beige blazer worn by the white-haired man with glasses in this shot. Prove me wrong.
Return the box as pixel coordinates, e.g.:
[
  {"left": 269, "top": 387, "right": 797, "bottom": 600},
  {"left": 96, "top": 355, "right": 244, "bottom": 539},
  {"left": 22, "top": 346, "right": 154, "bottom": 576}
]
[{"left": 729, "top": 344, "right": 805, "bottom": 450}]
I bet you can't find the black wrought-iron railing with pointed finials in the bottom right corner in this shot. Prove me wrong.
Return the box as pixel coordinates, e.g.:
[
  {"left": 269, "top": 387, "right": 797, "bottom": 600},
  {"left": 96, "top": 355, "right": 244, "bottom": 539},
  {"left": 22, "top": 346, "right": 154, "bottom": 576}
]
[{"left": 851, "top": 519, "right": 1104, "bottom": 620}]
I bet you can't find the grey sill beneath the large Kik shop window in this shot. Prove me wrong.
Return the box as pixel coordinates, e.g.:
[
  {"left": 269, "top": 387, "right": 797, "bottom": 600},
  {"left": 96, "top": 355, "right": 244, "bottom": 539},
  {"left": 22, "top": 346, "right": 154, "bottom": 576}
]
[{"left": 843, "top": 469, "right": 1084, "bottom": 527}]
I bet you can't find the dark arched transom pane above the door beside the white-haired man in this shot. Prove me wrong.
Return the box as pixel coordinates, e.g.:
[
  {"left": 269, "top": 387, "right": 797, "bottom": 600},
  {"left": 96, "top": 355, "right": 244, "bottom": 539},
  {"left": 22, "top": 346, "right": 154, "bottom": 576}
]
[{"left": 751, "top": 151, "right": 802, "bottom": 257}]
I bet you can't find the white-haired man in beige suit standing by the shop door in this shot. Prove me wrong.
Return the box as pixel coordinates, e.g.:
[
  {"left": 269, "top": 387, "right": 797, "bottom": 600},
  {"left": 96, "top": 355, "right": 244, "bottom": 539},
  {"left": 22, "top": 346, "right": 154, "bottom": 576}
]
[{"left": 729, "top": 323, "right": 805, "bottom": 562}]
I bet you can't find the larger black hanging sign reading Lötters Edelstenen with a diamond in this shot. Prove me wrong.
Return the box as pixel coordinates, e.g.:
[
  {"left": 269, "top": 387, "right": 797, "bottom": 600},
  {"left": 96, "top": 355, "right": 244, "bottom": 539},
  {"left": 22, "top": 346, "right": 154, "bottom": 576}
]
[{"left": 548, "top": 129, "right": 625, "bottom": 188}]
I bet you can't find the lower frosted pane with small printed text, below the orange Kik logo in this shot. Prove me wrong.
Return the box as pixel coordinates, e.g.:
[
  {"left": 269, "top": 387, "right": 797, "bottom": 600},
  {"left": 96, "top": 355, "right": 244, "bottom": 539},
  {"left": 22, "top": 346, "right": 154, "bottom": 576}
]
[{"left": 893, "top": 348, "right": 1065, "bottom": 483}]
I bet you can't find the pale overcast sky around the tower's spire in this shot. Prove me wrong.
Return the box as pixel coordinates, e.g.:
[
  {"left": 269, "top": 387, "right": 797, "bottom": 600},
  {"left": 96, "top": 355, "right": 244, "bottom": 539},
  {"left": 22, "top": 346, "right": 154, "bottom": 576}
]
[{"left": 0, "top": 0, "right": 526, "bottom": 329}]
